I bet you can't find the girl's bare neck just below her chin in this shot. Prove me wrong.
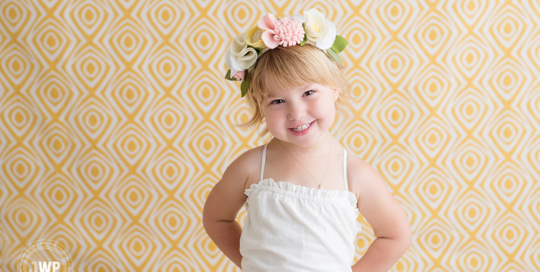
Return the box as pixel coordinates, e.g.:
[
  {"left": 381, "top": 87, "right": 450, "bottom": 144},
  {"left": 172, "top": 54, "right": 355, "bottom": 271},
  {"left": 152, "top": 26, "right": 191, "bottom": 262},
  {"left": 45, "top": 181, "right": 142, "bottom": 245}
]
[{"left": 268, "top": 131, "right": 335, "bottom": 157}]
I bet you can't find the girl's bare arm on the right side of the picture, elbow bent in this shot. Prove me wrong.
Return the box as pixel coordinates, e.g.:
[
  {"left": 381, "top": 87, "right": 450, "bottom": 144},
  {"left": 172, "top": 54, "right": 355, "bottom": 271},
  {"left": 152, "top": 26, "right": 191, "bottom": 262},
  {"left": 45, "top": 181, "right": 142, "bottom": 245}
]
[{"left": 349, "top": 158, "right": 412, "bottom": 272}]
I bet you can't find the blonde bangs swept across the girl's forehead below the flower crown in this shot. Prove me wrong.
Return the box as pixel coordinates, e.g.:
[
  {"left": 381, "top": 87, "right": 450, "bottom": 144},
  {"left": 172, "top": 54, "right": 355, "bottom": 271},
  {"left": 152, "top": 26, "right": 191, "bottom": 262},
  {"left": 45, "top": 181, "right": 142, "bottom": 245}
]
[{"left": 250, "top": 45, "right": 339, "bottom": 98}]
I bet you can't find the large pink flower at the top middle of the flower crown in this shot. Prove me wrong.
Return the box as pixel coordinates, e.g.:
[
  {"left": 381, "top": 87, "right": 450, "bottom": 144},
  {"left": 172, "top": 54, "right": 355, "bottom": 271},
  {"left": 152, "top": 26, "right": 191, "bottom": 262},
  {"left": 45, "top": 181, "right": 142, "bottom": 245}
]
[{"left": 258, "top": 12, "right": 305, "bottom": 49}]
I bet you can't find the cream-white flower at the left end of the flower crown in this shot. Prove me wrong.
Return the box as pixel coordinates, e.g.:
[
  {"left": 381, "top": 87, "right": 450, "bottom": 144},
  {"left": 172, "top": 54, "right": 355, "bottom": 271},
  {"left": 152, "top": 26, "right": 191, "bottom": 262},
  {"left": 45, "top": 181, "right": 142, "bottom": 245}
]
[{"left": 225, "top": 34, "right": 257, "bottom": 71}]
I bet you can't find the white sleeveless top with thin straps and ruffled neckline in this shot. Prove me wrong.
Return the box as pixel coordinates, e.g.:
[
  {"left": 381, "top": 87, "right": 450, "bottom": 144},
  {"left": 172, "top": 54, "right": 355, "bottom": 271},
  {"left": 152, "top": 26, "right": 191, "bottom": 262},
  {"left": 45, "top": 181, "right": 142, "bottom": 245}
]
[{"left": 240, "top": 145, "right": 361, "bottom": 272}]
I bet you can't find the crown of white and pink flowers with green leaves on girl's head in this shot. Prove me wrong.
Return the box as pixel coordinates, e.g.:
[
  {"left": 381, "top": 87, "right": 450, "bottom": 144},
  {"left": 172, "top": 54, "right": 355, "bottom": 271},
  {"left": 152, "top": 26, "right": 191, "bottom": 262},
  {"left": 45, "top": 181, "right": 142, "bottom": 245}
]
[{"left": 225, "top": 9, "right": 348, "bottom": 97}]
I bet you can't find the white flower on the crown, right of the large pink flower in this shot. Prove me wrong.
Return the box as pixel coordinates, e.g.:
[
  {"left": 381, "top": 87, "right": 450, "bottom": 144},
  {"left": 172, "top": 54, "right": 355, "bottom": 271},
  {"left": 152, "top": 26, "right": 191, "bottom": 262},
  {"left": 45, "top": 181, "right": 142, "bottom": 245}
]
[{"left": 304, "top": 9, "right": 336, "bottom": 50}]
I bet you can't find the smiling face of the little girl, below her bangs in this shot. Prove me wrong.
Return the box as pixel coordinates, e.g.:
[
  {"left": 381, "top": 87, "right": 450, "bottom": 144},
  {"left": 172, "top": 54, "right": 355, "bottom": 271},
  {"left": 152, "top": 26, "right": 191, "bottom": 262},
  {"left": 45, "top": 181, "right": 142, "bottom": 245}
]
[{"left": 263, "top": 83, "right": 339, "bottom": 147}]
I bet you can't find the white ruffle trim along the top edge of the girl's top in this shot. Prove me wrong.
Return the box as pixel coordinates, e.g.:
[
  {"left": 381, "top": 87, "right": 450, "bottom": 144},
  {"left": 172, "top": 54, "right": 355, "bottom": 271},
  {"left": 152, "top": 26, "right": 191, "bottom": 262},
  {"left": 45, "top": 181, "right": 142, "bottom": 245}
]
[{"left": 244, "top": 178, "right": 360, "bottom": 207}]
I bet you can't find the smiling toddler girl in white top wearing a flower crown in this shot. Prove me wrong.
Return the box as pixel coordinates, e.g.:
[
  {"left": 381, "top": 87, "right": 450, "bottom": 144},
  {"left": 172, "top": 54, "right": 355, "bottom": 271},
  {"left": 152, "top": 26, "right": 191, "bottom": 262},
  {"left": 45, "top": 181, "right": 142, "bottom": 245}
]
[{"left": 203, "top": 9, "right": 411, "bottom": 272}]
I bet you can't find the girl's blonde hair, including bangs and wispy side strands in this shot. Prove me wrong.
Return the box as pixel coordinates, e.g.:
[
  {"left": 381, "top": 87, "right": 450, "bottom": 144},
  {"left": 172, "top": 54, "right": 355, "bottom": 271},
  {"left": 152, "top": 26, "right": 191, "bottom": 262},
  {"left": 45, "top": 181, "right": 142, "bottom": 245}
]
[{"left": 234, "top": 44, "right": 351, "bottom": 140}]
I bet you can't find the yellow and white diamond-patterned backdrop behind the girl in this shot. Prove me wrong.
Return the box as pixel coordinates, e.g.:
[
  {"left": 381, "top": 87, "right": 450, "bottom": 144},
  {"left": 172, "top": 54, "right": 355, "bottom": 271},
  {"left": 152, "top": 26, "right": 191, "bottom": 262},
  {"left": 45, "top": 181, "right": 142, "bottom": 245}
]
[{"left": 0, "top": 0, "right": 540, "bottom": 271}]
